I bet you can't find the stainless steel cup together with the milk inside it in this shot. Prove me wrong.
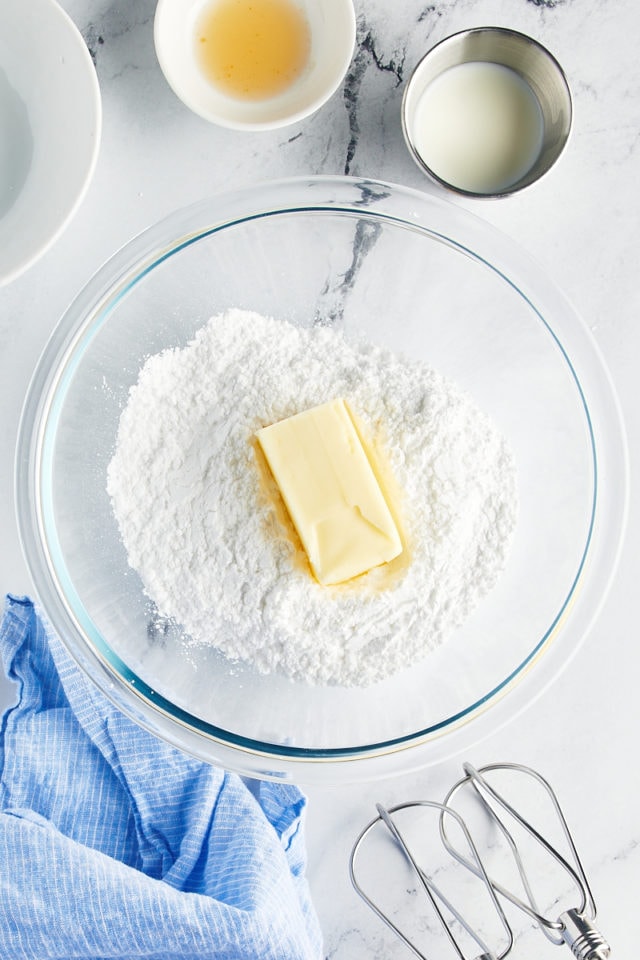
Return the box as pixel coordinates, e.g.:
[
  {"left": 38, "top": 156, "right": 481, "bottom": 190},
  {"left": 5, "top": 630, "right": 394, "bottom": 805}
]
[{"left": 402, "top": 27, "right": 572, "bottom": 197}]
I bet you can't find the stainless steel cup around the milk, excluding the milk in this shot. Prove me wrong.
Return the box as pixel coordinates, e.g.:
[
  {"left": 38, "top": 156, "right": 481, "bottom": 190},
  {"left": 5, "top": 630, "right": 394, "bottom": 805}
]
[{"left": 402, "top": 27, "right": 573, "bottom": 197}]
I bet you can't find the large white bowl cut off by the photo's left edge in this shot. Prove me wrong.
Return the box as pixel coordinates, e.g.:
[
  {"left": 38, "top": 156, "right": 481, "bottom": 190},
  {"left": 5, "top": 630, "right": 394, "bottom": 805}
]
[{"left": 0, "top": 0, "right": 102, "bottom": 285}]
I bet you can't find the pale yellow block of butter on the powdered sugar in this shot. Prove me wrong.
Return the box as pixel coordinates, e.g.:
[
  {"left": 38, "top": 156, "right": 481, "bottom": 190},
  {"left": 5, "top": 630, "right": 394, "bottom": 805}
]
[{"left": 256, "top": 400, "right": 402, "bottom": 585}]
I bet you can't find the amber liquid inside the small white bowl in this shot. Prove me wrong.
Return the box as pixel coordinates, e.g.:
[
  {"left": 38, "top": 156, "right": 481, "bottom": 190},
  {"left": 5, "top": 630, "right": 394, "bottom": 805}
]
[{"left": 196, "top": 0, "right": 311, "bottom": 100}]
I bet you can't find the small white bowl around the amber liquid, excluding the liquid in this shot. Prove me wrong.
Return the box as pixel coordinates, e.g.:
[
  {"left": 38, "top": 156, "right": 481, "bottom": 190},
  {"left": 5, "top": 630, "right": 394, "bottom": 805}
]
[{"left": 154, "top": 0, "right": 356, "bottom": 130}]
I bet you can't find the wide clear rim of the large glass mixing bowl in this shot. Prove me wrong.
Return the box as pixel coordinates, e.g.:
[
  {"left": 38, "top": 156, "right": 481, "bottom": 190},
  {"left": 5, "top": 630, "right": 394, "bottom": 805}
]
[{"left": 15, "top": 176, "right": 629, "bottom": 782}]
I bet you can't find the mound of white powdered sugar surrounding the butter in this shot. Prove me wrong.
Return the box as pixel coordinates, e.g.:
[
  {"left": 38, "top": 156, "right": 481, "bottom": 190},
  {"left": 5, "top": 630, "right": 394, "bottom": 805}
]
[{"left": 108, "top": 310, "right": 517, "bottom": 685}]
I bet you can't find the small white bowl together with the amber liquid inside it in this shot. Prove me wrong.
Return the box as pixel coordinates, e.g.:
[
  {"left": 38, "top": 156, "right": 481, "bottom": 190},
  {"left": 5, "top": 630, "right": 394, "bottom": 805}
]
[{"left": 153, "top": 0, "right": 356, "bottom": 131}]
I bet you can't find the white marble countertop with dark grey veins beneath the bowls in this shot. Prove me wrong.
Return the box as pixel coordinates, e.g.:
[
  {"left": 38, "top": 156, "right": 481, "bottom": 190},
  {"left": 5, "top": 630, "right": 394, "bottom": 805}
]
[{"left": 0, "top": 0, "right": 640, "bottom": 960}]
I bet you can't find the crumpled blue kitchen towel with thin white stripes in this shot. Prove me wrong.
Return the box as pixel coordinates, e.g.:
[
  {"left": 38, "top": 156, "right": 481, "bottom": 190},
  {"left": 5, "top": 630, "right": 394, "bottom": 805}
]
[{"left": 0, "top": 597, "right": 322, "bottom": 960}]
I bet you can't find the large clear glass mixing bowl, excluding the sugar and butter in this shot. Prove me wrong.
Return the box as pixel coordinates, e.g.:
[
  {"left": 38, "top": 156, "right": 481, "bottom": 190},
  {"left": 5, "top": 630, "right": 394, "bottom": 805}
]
[{"left": 17, "top": 177, "right": 627, "bottom": 782}]
